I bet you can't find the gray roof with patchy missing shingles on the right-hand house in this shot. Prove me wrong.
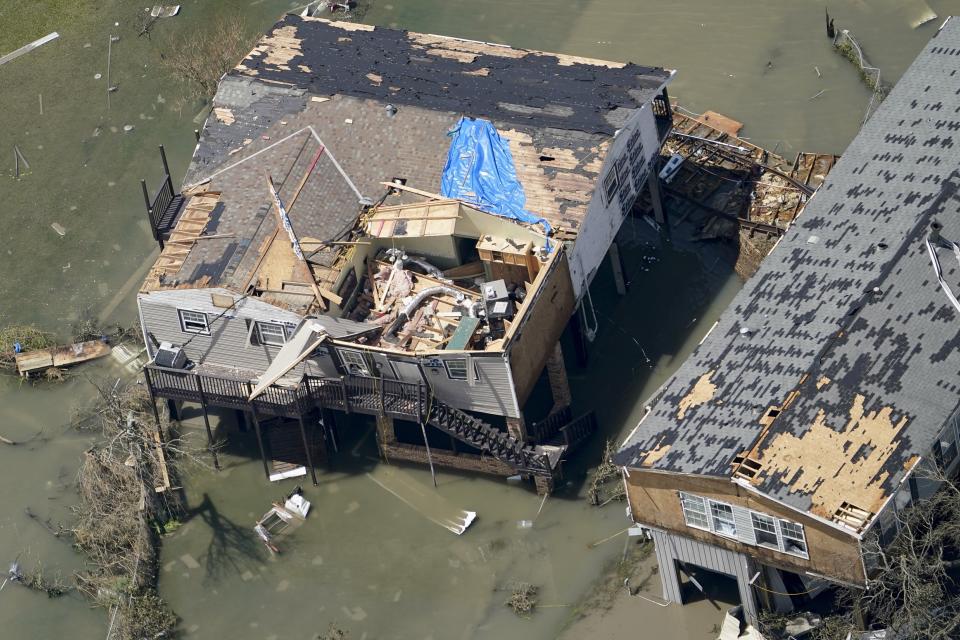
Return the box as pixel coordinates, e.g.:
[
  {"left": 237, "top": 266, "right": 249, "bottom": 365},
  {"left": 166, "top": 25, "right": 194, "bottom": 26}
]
[{"left": 616, "top": 19, "right": 960, "bottom": 518}]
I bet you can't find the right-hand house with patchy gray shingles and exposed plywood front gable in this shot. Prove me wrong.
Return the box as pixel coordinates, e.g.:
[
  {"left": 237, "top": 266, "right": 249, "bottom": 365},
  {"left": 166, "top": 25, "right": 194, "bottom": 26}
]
[{"left": 615, "top": 19, "right": 960, "bottom": 615}]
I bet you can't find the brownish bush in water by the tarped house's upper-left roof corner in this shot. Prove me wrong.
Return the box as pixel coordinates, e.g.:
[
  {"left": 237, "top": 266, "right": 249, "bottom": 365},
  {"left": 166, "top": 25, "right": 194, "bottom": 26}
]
[{"left": 163, "top": 16, "right": 255, "bottom": 99}]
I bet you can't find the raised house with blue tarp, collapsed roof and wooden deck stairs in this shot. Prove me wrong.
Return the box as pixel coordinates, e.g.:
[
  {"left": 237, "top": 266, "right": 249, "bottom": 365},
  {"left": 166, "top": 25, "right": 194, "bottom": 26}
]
[{"left": 138, "top": 15, "right": 672, "bottom": 490}]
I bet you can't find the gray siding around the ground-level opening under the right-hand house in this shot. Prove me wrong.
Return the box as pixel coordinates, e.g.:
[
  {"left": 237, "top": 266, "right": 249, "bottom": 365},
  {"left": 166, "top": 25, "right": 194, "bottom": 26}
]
[{"left": 650, "top": 529, "right": 757, "bottom": 618}]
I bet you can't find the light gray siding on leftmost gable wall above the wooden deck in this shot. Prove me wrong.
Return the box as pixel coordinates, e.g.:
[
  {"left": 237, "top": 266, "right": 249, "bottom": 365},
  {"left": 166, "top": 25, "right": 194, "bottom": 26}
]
[{"left": 138, "top": 289, "right": 302, "bottom": 376}]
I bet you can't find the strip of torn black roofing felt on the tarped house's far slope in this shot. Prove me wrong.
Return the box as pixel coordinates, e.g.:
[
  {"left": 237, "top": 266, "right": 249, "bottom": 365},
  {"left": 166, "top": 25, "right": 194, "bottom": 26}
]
[{"left": 230, "top": 15, "right": 670, "bottom": 136}]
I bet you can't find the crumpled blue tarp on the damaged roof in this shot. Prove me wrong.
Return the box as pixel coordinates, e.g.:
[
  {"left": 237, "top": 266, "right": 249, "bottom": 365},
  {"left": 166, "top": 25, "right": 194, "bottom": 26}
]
[{"left": 440, "top": 118, "right": 551, "bottom": 235}]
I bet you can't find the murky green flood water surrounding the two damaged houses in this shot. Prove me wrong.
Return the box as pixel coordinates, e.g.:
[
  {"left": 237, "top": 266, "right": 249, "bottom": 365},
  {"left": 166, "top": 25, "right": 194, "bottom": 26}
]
[{"left": 0, "top": 0, "right": 960, "bottom": 639}]
